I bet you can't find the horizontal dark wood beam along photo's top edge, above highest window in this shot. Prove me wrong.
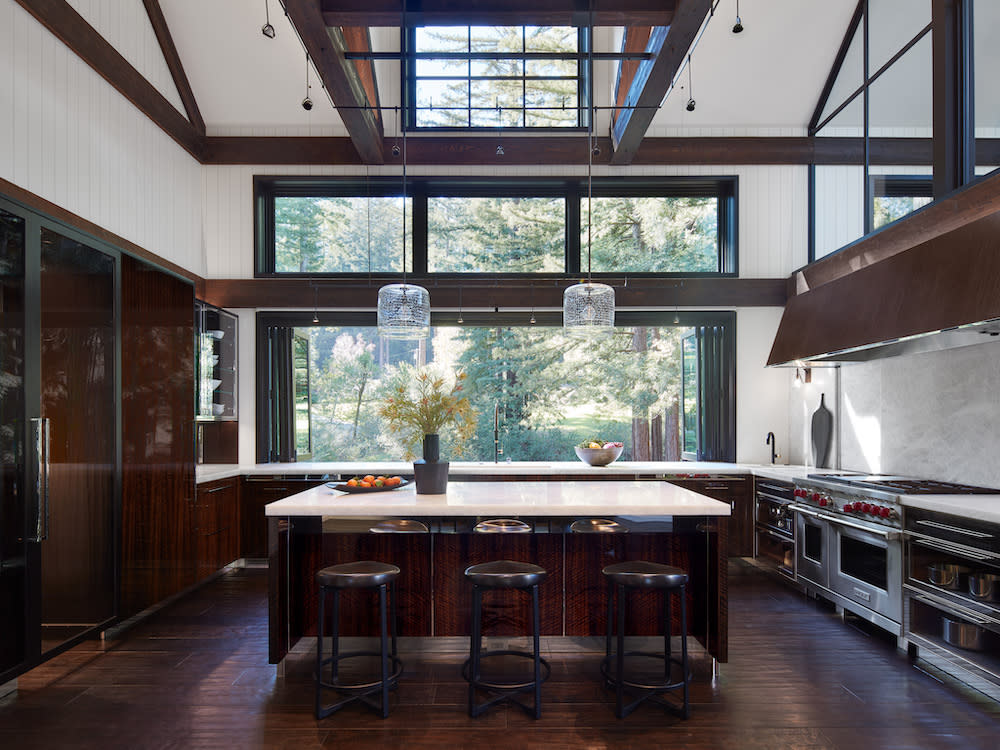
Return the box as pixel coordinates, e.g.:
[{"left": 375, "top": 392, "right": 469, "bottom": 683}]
[{"left": 321, "top": 0, "right": 677, "bottom": 26}]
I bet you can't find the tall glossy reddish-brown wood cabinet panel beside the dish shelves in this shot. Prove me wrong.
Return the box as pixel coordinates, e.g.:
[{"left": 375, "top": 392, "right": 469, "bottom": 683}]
[{"left": 121, "top": 257, "right": 197, "bottom": 617}]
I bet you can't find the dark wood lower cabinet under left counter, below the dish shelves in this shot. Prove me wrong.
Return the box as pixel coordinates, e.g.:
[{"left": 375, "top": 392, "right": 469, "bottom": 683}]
[{"left": 194, "top": 477, "right": 240, "bottom": 581}]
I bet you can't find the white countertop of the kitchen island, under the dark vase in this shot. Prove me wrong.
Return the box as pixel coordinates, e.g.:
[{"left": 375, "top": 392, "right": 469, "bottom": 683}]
[{"left": 265, "top": 481, "right": 730, "bottom": 518}]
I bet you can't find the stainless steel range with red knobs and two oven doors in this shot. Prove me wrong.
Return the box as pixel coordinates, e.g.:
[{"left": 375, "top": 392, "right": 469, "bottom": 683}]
[{"left": 792, "top": 474, "right": 992, "bottom": 636}]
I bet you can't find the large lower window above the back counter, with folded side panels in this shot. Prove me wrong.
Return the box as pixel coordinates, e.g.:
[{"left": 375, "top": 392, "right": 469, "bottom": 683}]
[{"left": 258, "top": 312, "right": 735, "bottom": 461}]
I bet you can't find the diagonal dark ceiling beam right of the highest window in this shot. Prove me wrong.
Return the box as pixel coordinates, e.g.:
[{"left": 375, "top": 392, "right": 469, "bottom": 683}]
[{"left": 611, "top": 0, "right": 712, "bottom": 165}]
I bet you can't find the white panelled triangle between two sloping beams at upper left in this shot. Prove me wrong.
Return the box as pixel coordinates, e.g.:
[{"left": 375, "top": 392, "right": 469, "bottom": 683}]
[{"left": 68, "top": 0, "right": 185, "bottom": 114}]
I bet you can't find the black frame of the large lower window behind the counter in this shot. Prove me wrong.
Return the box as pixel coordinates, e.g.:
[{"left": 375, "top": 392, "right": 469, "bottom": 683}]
[{"left": 256, "top": 310, "right": 737, "bottom": 463}]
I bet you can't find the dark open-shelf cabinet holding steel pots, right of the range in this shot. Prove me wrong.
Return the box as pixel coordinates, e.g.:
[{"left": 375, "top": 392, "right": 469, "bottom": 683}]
[{"left": 903, "top": 507, "right": 1000, "bottom": 700}]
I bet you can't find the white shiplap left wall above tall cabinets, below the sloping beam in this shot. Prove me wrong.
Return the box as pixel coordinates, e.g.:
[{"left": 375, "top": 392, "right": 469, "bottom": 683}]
[{"left": 0, "top": 2, "right": 205, "bottom": 274}]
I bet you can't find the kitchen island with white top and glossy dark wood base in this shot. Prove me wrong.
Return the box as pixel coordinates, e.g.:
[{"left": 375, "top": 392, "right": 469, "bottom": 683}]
[{"left": 265, "top": 478, "right": 730, "bottom": 663}]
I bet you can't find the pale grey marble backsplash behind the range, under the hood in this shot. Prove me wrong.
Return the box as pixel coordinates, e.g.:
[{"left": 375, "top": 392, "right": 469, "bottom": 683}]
[{"left": 789, "top": 342, "right": 1000, "bottom": 488}]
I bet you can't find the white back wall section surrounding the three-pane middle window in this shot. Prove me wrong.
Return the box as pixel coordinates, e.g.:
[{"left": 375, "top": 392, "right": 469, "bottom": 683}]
[{"left": 203, "top": 160, "right": 808, "bottom": 278}]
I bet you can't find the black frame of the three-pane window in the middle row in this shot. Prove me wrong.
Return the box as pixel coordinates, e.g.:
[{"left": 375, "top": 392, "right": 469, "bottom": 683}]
[{"left": 253, "top": 175, "right": 739, "bottom": 280}]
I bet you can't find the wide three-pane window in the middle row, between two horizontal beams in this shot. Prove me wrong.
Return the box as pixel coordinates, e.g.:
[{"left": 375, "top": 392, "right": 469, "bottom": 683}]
[{"left": 255, "top": 177, "right": 737, "bottom": 276}]
